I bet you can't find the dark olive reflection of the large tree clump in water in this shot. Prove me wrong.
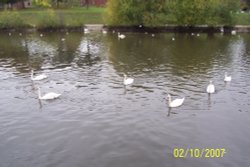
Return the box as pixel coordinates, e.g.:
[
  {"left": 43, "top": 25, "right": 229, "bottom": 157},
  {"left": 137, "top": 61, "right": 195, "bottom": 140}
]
[{"left": 109, "top": 33, "right": 230, "bottom": 73}]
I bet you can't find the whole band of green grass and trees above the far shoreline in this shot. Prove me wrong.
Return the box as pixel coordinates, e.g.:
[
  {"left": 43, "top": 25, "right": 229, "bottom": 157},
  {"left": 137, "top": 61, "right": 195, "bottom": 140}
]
[{"left": 0, "top": 0, "right": 250, "bottom": 29}]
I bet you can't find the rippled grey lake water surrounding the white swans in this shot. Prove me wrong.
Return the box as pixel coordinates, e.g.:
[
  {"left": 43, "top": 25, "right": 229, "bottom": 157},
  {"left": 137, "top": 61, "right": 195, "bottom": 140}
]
[{"left": 0, "top": 32, "right": 250, "bottom": 167}]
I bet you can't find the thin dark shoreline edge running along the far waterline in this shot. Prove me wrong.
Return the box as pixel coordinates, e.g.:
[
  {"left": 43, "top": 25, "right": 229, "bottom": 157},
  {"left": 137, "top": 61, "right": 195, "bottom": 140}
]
[{"left": 0, "top": 24, "right": 250, "bottom": 33}]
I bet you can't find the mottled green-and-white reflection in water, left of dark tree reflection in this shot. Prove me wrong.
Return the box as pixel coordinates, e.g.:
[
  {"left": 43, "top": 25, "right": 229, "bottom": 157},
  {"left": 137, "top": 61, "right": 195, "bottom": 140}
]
[{"left": 0, "top": 33, "right": 104, "bottom": 71}]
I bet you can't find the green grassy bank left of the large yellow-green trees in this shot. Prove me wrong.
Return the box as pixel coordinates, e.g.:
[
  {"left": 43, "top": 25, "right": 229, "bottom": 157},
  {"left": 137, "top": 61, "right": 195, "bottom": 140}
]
[{"left": 0, "top": 7, "right": 104, "bottom": 29}]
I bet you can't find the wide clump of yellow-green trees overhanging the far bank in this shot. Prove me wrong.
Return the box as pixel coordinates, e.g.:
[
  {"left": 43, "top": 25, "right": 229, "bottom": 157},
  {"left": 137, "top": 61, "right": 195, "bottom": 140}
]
[{"left": 105, "top": 0, "right": 240, "bottom": 26}]
